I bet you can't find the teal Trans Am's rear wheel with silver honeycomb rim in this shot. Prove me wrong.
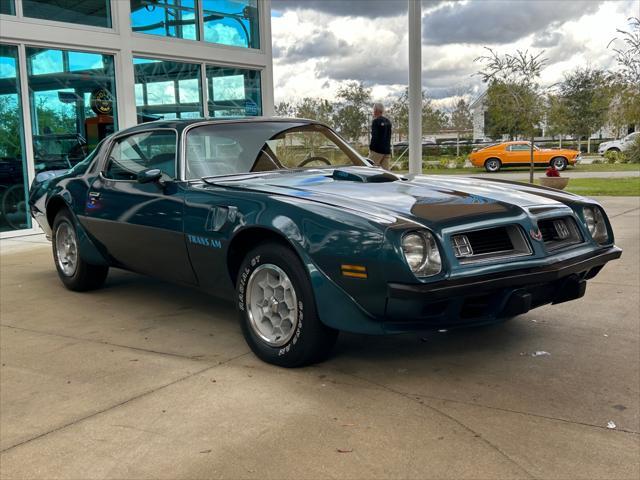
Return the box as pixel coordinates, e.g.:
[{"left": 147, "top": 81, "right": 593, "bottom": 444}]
[{"left": 51, "top": 210, "right": 109, "bottom": 292}]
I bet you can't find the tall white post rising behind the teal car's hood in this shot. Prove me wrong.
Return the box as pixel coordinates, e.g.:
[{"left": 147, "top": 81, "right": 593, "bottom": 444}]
[{"left": 408, "top": 0, "right": 422, "bottom": 174}]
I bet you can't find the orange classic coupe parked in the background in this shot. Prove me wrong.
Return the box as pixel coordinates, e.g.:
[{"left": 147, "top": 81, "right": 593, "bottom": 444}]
[{"left": 469, "top": 141, "right": 580, "bottom": 172}]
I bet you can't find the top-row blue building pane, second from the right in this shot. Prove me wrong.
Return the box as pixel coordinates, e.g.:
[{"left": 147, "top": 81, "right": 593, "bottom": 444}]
[{"left": 131, "top": 0, "right": 198, "bottom": 40}]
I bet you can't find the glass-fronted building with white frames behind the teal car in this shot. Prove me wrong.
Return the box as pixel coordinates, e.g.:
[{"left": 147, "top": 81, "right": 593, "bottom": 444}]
[{"left": 0, "top": 0, "right": 273, "bottom": 237}]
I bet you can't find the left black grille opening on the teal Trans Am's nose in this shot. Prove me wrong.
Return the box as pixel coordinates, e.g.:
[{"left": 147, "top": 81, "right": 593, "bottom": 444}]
[{"left": 451, "top": 225, "right": 531, "bottom": 263}]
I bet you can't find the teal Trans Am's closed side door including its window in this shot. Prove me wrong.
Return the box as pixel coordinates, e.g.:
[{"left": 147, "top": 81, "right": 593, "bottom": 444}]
[{"left": 84, "top": 129, "right": 196, "bottom": 283}]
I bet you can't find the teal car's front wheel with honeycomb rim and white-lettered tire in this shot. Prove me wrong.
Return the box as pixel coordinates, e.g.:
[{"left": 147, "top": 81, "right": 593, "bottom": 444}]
[{"left": 236, "top": 243, "right": 338, "bottom": 367}]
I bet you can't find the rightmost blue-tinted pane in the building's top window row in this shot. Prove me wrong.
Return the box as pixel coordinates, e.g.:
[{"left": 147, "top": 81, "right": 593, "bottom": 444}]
[{"left": 202, "top": 0, "right": 260, "bottom": 48}]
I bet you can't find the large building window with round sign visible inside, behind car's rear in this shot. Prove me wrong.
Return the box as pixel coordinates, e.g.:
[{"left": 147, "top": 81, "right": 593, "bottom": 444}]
[{"left": 26, "top": 47, "right": 117, "bottom": 173}]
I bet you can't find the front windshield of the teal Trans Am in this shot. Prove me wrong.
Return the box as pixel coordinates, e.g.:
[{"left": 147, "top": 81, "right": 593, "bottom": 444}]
[{"left": 185, "top": 122, "right": 366, "bottom": 180}]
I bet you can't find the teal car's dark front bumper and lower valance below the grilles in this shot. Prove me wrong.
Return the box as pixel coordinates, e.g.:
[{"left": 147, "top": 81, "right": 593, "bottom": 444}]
[{"left": 384, "top": 246, "right": 622, "bottom": 332}]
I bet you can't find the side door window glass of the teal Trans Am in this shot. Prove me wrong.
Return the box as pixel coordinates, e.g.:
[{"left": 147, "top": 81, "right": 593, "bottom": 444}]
[{"left": 103, "top": 130, "right": 177, "bottom": 180}]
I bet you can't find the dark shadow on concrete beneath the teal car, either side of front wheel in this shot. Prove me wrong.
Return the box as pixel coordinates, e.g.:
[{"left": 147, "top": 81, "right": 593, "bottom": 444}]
[{"left": 89, "top": 269, "right": 537, "bottom": 365}]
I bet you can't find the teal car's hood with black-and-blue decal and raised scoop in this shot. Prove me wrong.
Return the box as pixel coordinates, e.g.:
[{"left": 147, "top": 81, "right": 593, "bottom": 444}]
[{"left": 215, "top": 167, "right": 579, "bottom": 227}]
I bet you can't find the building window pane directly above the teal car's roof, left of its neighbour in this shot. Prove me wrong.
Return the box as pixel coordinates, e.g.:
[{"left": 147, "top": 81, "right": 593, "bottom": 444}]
[{"left": 133, "top": 58, "right": 203, "bottom": 123}]
